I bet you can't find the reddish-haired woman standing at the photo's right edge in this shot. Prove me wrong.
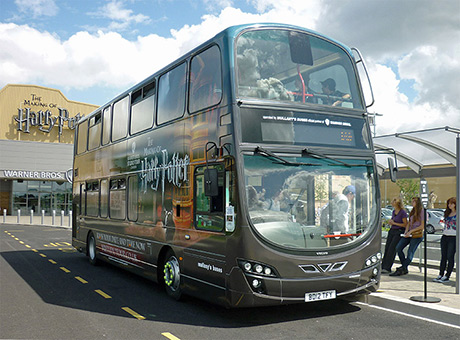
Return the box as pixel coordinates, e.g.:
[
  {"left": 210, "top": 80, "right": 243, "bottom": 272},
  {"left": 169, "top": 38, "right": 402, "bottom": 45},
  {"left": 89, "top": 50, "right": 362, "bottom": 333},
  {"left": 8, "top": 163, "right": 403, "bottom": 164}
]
[{"left": 433, "top": 197, "right": 457, "bottom": 282}]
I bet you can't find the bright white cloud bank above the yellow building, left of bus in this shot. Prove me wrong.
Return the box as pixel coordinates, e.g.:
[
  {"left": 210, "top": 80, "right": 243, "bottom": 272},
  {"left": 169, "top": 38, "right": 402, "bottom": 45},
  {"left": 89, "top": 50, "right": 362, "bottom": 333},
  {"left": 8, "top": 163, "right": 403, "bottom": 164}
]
[{"left": 0, "top": 24, "right": 175, "bottom": 89}]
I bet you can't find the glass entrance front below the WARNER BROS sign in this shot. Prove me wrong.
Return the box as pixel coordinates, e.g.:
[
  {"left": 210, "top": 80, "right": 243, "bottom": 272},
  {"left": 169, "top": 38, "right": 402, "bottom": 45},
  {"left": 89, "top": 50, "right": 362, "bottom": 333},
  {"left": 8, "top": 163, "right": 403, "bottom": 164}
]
[{"left": 10, "top": 180, "right": 72, "bottom": 215}]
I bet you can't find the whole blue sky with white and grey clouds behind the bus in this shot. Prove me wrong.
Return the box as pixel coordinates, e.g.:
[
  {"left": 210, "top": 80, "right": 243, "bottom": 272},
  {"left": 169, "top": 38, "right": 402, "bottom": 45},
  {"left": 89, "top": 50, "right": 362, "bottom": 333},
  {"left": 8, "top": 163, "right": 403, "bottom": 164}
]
[{"left": 0, "top": 0, "right": 460, "bottom": 135}]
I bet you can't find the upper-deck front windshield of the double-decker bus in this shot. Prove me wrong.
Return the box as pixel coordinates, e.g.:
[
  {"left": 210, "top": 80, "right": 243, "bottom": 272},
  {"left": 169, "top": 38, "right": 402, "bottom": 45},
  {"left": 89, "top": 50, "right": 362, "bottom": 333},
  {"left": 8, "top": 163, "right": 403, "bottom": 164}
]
[{"left": 236, "top": 29, "right": 363, "bottom": 109}]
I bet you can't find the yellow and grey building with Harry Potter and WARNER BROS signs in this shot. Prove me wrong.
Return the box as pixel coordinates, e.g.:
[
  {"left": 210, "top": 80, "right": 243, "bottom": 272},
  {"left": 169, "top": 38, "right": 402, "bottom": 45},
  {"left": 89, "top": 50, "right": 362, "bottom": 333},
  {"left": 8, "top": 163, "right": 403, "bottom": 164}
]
[{"left": 0, "top": 84, "right": 98, "bottom": 215}]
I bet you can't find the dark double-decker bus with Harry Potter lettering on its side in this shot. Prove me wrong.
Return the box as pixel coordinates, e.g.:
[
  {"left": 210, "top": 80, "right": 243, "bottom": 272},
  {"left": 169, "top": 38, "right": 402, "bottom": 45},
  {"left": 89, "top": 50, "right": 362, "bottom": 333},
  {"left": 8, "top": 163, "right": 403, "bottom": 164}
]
[{"left": 72, "top": 24, "right": 381, "bottom": 307}]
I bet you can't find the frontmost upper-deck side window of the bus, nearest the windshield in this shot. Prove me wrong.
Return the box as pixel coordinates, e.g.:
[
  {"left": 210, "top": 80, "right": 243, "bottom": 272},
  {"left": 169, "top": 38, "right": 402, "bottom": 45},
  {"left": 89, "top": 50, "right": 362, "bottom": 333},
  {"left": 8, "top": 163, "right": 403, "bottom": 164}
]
[{"left": 189, "top": 45, "right": 222, "bottom": 113}]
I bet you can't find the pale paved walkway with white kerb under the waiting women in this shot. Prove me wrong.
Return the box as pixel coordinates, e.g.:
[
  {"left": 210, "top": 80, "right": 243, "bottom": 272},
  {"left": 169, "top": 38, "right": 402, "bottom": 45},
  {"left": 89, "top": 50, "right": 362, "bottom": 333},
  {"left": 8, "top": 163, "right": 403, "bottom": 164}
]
[{"left": 365, "top": 266, "right": 460, "bottom": 327}]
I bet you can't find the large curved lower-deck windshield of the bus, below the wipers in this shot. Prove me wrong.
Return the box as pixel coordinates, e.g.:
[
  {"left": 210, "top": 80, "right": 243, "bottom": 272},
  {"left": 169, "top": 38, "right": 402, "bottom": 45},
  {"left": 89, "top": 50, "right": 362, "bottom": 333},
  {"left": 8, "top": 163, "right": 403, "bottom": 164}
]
[{"left": 244, "top": 152, "right": 378, "bottom": 251}]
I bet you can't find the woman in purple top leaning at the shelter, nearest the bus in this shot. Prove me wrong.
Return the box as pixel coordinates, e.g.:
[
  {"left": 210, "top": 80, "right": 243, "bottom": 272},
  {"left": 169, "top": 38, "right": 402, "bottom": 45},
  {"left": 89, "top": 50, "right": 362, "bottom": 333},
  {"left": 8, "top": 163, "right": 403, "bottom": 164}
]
[{"left": 382, "top": 198, "right": 407, "bottom": 274}]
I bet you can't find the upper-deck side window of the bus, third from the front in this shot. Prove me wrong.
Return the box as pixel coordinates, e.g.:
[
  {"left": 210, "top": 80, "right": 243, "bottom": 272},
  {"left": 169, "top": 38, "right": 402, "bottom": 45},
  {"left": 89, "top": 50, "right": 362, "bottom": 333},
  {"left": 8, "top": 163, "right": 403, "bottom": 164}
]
[{"left": 130, "top": 82, "right": 155, "bottom": 135}]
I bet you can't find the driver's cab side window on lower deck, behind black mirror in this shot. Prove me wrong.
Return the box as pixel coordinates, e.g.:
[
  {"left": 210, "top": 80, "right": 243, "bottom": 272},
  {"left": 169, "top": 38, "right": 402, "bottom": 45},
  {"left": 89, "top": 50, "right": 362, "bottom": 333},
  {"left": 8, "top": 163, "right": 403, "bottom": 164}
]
[{"left": 194, "top": 165, "right": 225, "bottom": 231}]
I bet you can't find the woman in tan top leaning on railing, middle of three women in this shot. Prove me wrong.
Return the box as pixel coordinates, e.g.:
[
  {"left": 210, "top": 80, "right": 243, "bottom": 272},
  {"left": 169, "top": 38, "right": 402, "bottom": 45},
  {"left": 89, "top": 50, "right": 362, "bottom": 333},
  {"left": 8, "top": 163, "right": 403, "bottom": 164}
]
[{"left": 390, "top": 197, "right": 425, "bottom": 276}]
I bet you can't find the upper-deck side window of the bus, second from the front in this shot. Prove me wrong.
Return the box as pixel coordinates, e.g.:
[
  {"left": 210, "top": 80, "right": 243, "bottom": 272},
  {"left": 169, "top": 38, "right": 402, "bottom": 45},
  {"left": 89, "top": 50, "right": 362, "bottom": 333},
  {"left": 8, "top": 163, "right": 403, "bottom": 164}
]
[{"left": 157, "top": 63, "right": 186, "bottom": 125}]
